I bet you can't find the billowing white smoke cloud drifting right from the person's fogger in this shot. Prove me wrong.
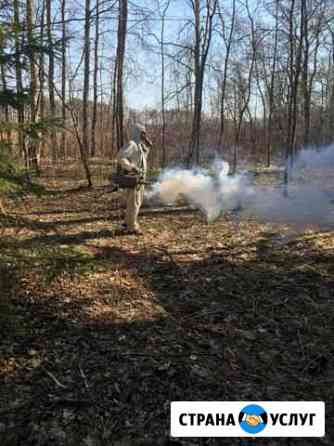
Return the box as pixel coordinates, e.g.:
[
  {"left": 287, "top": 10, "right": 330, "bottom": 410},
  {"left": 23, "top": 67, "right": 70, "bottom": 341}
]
[{"left": 146, "top": 145, "right": 334, "bottom": 225}]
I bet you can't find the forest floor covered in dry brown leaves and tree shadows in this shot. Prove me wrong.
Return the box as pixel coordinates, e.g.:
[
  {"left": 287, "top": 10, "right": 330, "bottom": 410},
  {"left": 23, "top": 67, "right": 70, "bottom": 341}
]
[{"left": 0, "top": 173, "right": 334, "bottom": 446}]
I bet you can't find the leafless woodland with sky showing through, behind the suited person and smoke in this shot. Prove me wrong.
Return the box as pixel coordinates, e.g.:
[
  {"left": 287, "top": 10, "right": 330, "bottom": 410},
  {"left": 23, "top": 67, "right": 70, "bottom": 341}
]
[{"left": 0, "top": 0, "right": 334, "bottom": 185}]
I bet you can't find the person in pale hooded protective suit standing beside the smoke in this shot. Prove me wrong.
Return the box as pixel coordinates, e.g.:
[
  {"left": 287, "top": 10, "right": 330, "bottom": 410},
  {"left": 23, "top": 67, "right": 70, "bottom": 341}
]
[{"left": 116, "top": 124, "right": 152, "bottom": 235}]
